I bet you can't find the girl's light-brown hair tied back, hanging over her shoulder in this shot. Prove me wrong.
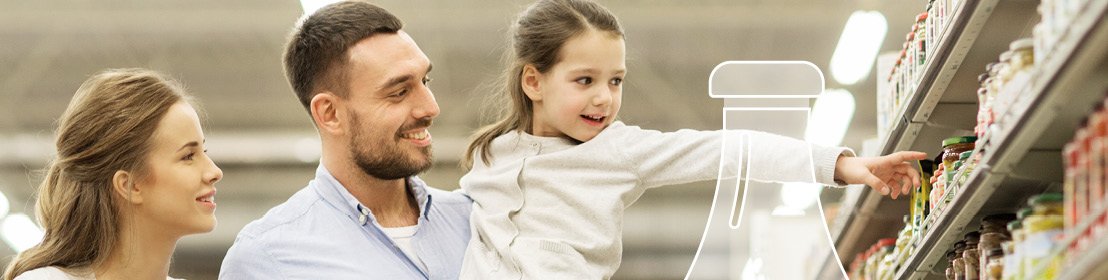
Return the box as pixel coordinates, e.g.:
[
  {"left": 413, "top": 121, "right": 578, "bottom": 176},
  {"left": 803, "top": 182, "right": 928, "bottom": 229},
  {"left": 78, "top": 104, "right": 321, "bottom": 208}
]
[{"left": 462, "top": 0, "right": 624, "bottom": 169}]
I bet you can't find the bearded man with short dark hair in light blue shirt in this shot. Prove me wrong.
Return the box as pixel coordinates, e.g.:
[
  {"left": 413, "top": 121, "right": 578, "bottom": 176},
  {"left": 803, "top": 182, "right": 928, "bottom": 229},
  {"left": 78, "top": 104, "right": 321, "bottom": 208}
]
[{"left": 219, "top": 2, "right": 472, "bottom": 279}]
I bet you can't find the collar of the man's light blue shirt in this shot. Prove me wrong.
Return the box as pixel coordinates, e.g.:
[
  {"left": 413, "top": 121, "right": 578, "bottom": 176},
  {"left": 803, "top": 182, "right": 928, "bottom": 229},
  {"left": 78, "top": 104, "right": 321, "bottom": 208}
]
[{"left": 312, "top": 164, "right": 431, "bottom": 225}]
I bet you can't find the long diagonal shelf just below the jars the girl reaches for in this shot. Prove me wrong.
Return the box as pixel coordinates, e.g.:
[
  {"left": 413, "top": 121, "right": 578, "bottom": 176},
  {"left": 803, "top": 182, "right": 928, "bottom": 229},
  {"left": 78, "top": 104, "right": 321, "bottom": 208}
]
[{"left": 896, "top": 0, "right": 1108, "bottom": 279}]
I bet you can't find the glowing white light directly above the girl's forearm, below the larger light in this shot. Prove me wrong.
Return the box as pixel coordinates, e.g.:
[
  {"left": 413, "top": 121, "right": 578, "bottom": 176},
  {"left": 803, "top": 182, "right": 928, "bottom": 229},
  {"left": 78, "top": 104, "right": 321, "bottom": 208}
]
[{"left": 804, "top": 90, "right": 854, "bottom": 146}]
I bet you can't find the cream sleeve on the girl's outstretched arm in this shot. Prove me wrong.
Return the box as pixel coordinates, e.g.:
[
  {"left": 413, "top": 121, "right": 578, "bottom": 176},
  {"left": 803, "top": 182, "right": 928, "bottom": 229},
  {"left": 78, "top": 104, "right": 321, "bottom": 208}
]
[{"left": 613, "top": 126, "right": 854, "bottom": 188}]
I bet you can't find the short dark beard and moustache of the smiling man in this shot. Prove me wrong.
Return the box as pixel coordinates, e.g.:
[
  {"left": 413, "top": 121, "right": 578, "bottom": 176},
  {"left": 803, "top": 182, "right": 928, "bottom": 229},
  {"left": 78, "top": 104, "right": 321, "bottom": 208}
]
[{"left": 350, "top": 114, "right": 431, "bottom": 179}]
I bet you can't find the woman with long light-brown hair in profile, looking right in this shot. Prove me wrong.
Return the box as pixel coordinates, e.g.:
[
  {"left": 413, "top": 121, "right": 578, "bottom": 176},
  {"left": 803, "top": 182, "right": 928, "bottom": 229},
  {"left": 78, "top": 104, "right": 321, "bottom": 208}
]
[{"left": 3, "top": 69, "right": 223, "bottom": 280}]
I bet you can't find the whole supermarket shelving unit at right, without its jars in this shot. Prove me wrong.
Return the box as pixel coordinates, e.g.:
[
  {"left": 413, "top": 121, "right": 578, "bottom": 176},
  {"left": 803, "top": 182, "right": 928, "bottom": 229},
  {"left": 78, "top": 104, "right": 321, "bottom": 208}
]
[{"left": 821, "top": 0, "right": 1108, "bottom": 279}]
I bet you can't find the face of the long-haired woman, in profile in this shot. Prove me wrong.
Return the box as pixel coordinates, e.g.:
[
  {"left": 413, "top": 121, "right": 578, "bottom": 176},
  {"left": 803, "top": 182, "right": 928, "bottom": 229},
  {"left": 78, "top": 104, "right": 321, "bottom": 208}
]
[{"left": 135, "top": 102, "right": 223, "bottom": 236}]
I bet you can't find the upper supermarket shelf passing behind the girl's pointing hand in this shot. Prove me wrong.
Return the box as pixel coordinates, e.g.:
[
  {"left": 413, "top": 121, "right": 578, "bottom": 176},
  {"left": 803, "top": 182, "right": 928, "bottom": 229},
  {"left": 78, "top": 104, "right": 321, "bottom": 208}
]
[{"left": 831, "top": 0, "right": 1038, "bottom": 268}]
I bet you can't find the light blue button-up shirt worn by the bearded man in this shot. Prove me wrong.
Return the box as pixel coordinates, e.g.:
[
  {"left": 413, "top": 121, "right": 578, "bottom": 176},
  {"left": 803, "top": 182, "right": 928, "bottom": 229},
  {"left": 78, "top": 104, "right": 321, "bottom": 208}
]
[{"left": 219, "top": 165, "right": 472, "bottom": 279}]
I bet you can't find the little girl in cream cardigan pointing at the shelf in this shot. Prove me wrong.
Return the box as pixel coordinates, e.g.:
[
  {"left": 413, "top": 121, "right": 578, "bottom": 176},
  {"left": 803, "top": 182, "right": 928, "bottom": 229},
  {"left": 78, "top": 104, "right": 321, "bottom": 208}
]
[{"left": 460, "top": 0, "right": 926, "bottom": 279}]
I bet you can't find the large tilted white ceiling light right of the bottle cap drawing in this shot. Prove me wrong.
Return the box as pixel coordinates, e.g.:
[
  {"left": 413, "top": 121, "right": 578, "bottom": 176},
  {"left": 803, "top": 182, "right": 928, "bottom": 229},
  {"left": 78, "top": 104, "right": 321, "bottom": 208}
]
[{"left": 831, "top": 11, "right": 889, "bottom": 85}]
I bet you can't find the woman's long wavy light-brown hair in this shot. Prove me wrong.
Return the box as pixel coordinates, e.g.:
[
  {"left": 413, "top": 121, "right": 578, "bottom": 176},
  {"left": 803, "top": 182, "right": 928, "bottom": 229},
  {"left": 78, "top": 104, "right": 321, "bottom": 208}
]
[{"left": 3, "top": 69, "right": 191, "bottom": 280}]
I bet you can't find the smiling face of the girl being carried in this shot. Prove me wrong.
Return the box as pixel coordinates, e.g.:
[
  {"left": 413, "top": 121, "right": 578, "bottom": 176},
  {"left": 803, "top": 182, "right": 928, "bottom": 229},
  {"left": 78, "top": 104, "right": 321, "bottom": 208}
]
[{"left": 522, "top": 29, "right": 627, "bottom": 142}]
